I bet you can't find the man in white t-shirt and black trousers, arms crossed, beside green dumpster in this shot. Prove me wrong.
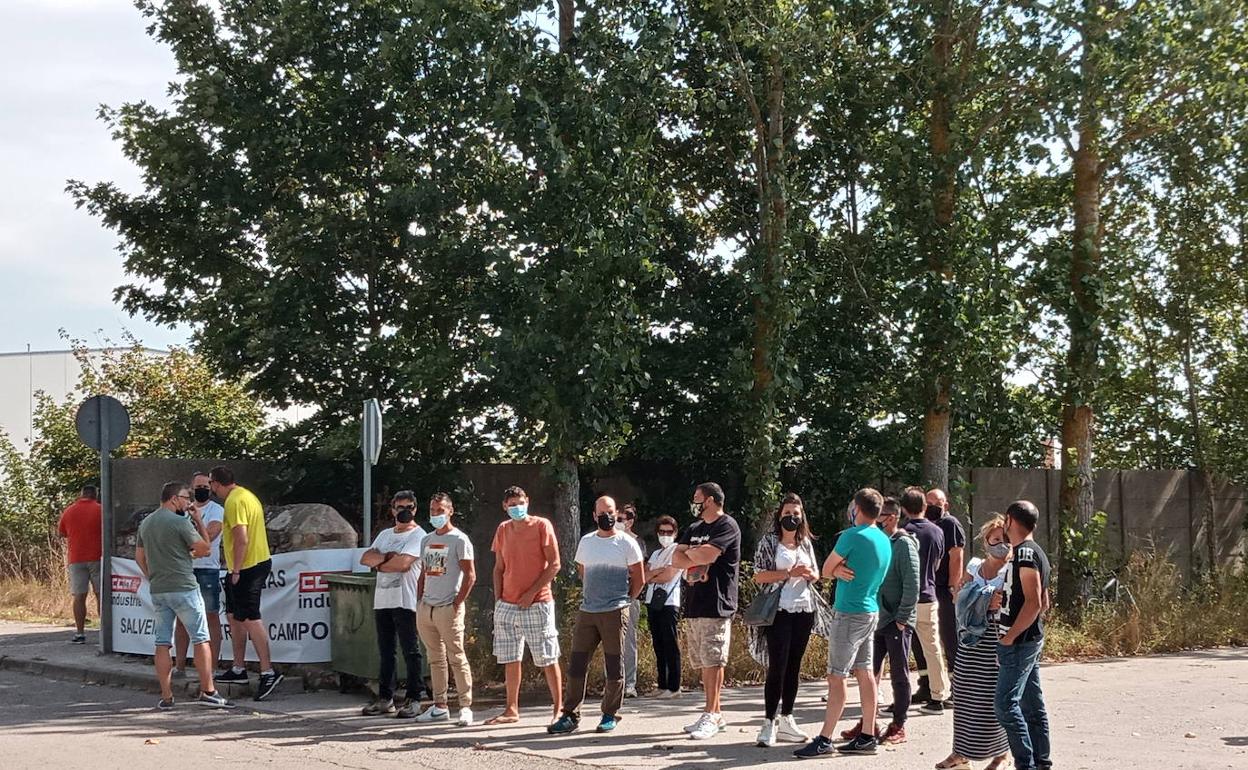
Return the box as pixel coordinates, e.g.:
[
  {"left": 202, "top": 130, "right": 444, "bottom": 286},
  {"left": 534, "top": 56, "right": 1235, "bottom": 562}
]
[{"left": 359, "top": 490, "right": 424, "bottom": 719}]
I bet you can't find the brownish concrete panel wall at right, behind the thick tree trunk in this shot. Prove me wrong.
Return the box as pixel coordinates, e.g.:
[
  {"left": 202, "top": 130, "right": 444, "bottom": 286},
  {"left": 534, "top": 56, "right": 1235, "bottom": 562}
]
[{"left": 956, "top": 468, "right": 1248, "bottom": 573}]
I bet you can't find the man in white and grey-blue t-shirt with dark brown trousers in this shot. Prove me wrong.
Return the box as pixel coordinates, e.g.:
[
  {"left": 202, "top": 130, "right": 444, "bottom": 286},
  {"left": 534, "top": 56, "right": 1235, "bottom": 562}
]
[{"left": 547, "top": 497, "right": 645, "bottom": 735}]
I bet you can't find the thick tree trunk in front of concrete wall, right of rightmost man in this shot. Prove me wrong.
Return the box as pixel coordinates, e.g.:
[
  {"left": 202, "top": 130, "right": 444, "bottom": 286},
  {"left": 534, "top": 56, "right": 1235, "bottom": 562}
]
[{"left": 1057, "top": 0, "right": 1102, "bottom": 609}]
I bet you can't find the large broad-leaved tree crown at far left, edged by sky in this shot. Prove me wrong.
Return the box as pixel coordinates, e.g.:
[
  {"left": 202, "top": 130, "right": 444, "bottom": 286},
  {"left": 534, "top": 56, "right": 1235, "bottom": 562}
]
[{"left": 70, "top": 0, "right": 508, "bottom": 463}]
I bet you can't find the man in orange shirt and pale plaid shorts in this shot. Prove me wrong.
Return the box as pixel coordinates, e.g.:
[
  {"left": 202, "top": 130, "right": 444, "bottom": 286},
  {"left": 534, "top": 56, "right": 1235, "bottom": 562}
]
[{"left": 485, "top": 487, "right": 563, "bottom": 725}]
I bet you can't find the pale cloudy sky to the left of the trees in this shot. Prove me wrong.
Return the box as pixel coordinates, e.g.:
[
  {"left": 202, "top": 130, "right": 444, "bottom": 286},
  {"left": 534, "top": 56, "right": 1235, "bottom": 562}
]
[{"left": 0, "top": 0, "right": 190, "bottom": 353}]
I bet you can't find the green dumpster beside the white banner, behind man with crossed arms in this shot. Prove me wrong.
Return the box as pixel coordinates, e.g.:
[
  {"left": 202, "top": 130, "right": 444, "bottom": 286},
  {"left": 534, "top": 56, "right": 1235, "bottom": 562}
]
[{"left": 324, "top": 573, "right": 429, "bottom": 688}]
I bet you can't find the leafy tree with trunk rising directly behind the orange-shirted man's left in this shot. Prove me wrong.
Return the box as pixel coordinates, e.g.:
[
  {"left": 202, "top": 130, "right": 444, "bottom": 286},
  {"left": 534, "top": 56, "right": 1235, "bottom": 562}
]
[{"left": 482, "top": 1, "right": 678, "bottom": 567}]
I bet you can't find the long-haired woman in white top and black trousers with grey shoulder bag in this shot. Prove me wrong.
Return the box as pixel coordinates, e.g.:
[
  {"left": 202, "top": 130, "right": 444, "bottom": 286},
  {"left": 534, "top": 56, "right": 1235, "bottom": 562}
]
[{"left": 750, "top": 492, "right": 827, "bottom": 746}]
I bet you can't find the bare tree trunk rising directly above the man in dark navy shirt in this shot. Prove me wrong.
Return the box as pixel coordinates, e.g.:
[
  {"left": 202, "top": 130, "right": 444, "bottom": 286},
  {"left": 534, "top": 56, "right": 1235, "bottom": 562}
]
[{"left": 922, "top": 0, "right": 957, "bottom": 490}]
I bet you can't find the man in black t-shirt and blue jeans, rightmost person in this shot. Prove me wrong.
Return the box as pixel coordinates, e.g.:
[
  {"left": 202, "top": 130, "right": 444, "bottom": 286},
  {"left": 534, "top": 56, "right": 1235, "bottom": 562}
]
[{"left": 993, "top": 500, "right": 1053, "bottom": 770}]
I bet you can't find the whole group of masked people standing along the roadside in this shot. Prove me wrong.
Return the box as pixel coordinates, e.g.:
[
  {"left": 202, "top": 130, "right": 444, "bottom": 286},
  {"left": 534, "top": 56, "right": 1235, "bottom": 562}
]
[{"left": 62, "top": 467, "right": 1051, "bottom": 770}]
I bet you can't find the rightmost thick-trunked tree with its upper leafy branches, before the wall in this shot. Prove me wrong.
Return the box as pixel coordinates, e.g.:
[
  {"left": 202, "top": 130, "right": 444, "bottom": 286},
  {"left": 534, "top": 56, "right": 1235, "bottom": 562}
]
[{"left": 1048, "top": 0, "right": 1244, "bottom": 612}]
